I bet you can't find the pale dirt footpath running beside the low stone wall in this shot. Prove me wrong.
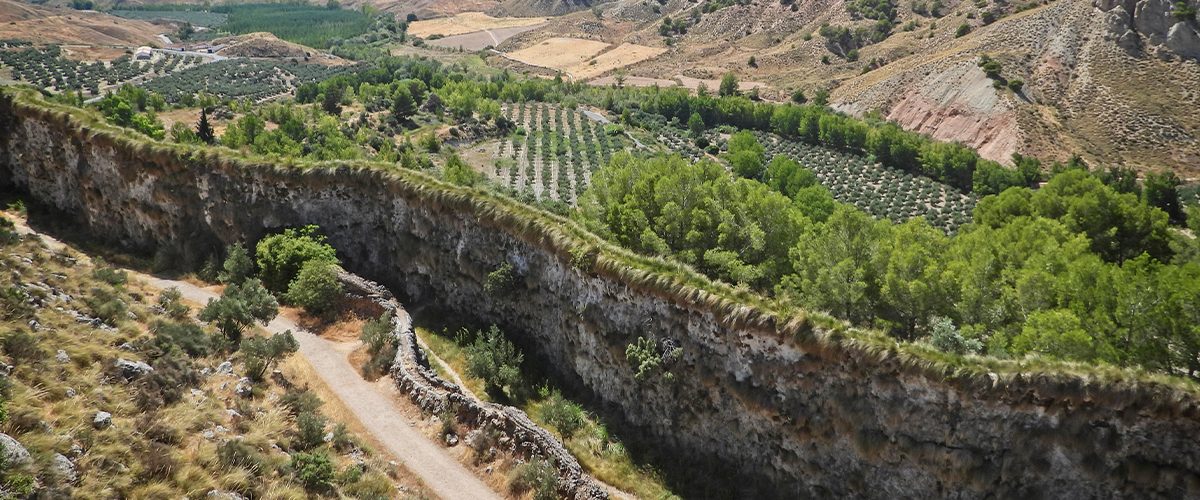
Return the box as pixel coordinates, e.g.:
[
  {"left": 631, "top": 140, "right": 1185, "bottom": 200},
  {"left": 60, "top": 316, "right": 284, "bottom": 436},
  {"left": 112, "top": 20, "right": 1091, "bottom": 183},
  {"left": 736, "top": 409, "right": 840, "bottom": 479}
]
[{"left": 11, "top": 217, "right": 500, "bottom": 500}]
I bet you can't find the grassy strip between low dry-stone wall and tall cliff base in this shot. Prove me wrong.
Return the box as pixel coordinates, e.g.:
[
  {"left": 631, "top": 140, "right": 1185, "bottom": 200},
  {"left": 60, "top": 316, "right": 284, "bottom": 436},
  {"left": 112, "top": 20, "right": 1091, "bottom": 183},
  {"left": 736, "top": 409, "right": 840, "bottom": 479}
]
[{"left": 415, "top": 326, "right": 677, "bottom": 499}]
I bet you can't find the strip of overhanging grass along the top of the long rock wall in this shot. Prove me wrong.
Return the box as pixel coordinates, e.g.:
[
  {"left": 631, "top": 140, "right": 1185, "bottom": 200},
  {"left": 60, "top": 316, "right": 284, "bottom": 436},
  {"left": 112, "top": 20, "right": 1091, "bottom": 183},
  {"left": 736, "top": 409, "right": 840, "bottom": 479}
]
[{"left": 7, "top": 86, "right": 1200, "bottom": 406}]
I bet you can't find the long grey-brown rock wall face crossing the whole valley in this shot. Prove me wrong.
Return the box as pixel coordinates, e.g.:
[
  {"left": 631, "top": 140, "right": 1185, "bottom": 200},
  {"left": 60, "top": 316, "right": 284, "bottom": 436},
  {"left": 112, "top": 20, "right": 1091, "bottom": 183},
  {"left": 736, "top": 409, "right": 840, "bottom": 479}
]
[{"left": 0, "top": 94, "right": 1200, "bottom": 499}]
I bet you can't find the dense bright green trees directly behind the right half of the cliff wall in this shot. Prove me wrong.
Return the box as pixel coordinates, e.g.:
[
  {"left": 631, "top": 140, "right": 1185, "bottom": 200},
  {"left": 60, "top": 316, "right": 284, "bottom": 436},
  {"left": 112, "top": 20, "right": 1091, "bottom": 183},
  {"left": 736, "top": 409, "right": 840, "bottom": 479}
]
[{"left": 577, "top": 152, "right": 1200, "bottom": 374}]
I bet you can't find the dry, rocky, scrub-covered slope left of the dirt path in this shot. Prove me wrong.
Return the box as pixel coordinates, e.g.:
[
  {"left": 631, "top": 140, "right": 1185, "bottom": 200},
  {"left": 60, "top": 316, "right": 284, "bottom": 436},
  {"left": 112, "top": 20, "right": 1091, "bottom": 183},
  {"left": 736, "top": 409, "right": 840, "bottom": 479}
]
[{"left": 0, "top": 231, "right": 408, "bottom": 499}]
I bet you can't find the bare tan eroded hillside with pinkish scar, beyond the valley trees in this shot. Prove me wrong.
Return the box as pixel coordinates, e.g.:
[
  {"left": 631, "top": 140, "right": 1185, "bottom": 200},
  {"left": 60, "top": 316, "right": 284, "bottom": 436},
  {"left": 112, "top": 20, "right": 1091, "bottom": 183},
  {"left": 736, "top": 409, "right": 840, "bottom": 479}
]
[{"left": 506, "top": 0, "right": 1200, "bottom": 176}]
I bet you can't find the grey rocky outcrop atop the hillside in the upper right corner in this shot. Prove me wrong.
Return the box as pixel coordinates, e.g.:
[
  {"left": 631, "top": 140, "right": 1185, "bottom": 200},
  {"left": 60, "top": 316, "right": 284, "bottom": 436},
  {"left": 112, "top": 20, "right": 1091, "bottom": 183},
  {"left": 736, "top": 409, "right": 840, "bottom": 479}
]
[{"left": 1092, "top": 0, "right": 1200, "bottom": 60}]
